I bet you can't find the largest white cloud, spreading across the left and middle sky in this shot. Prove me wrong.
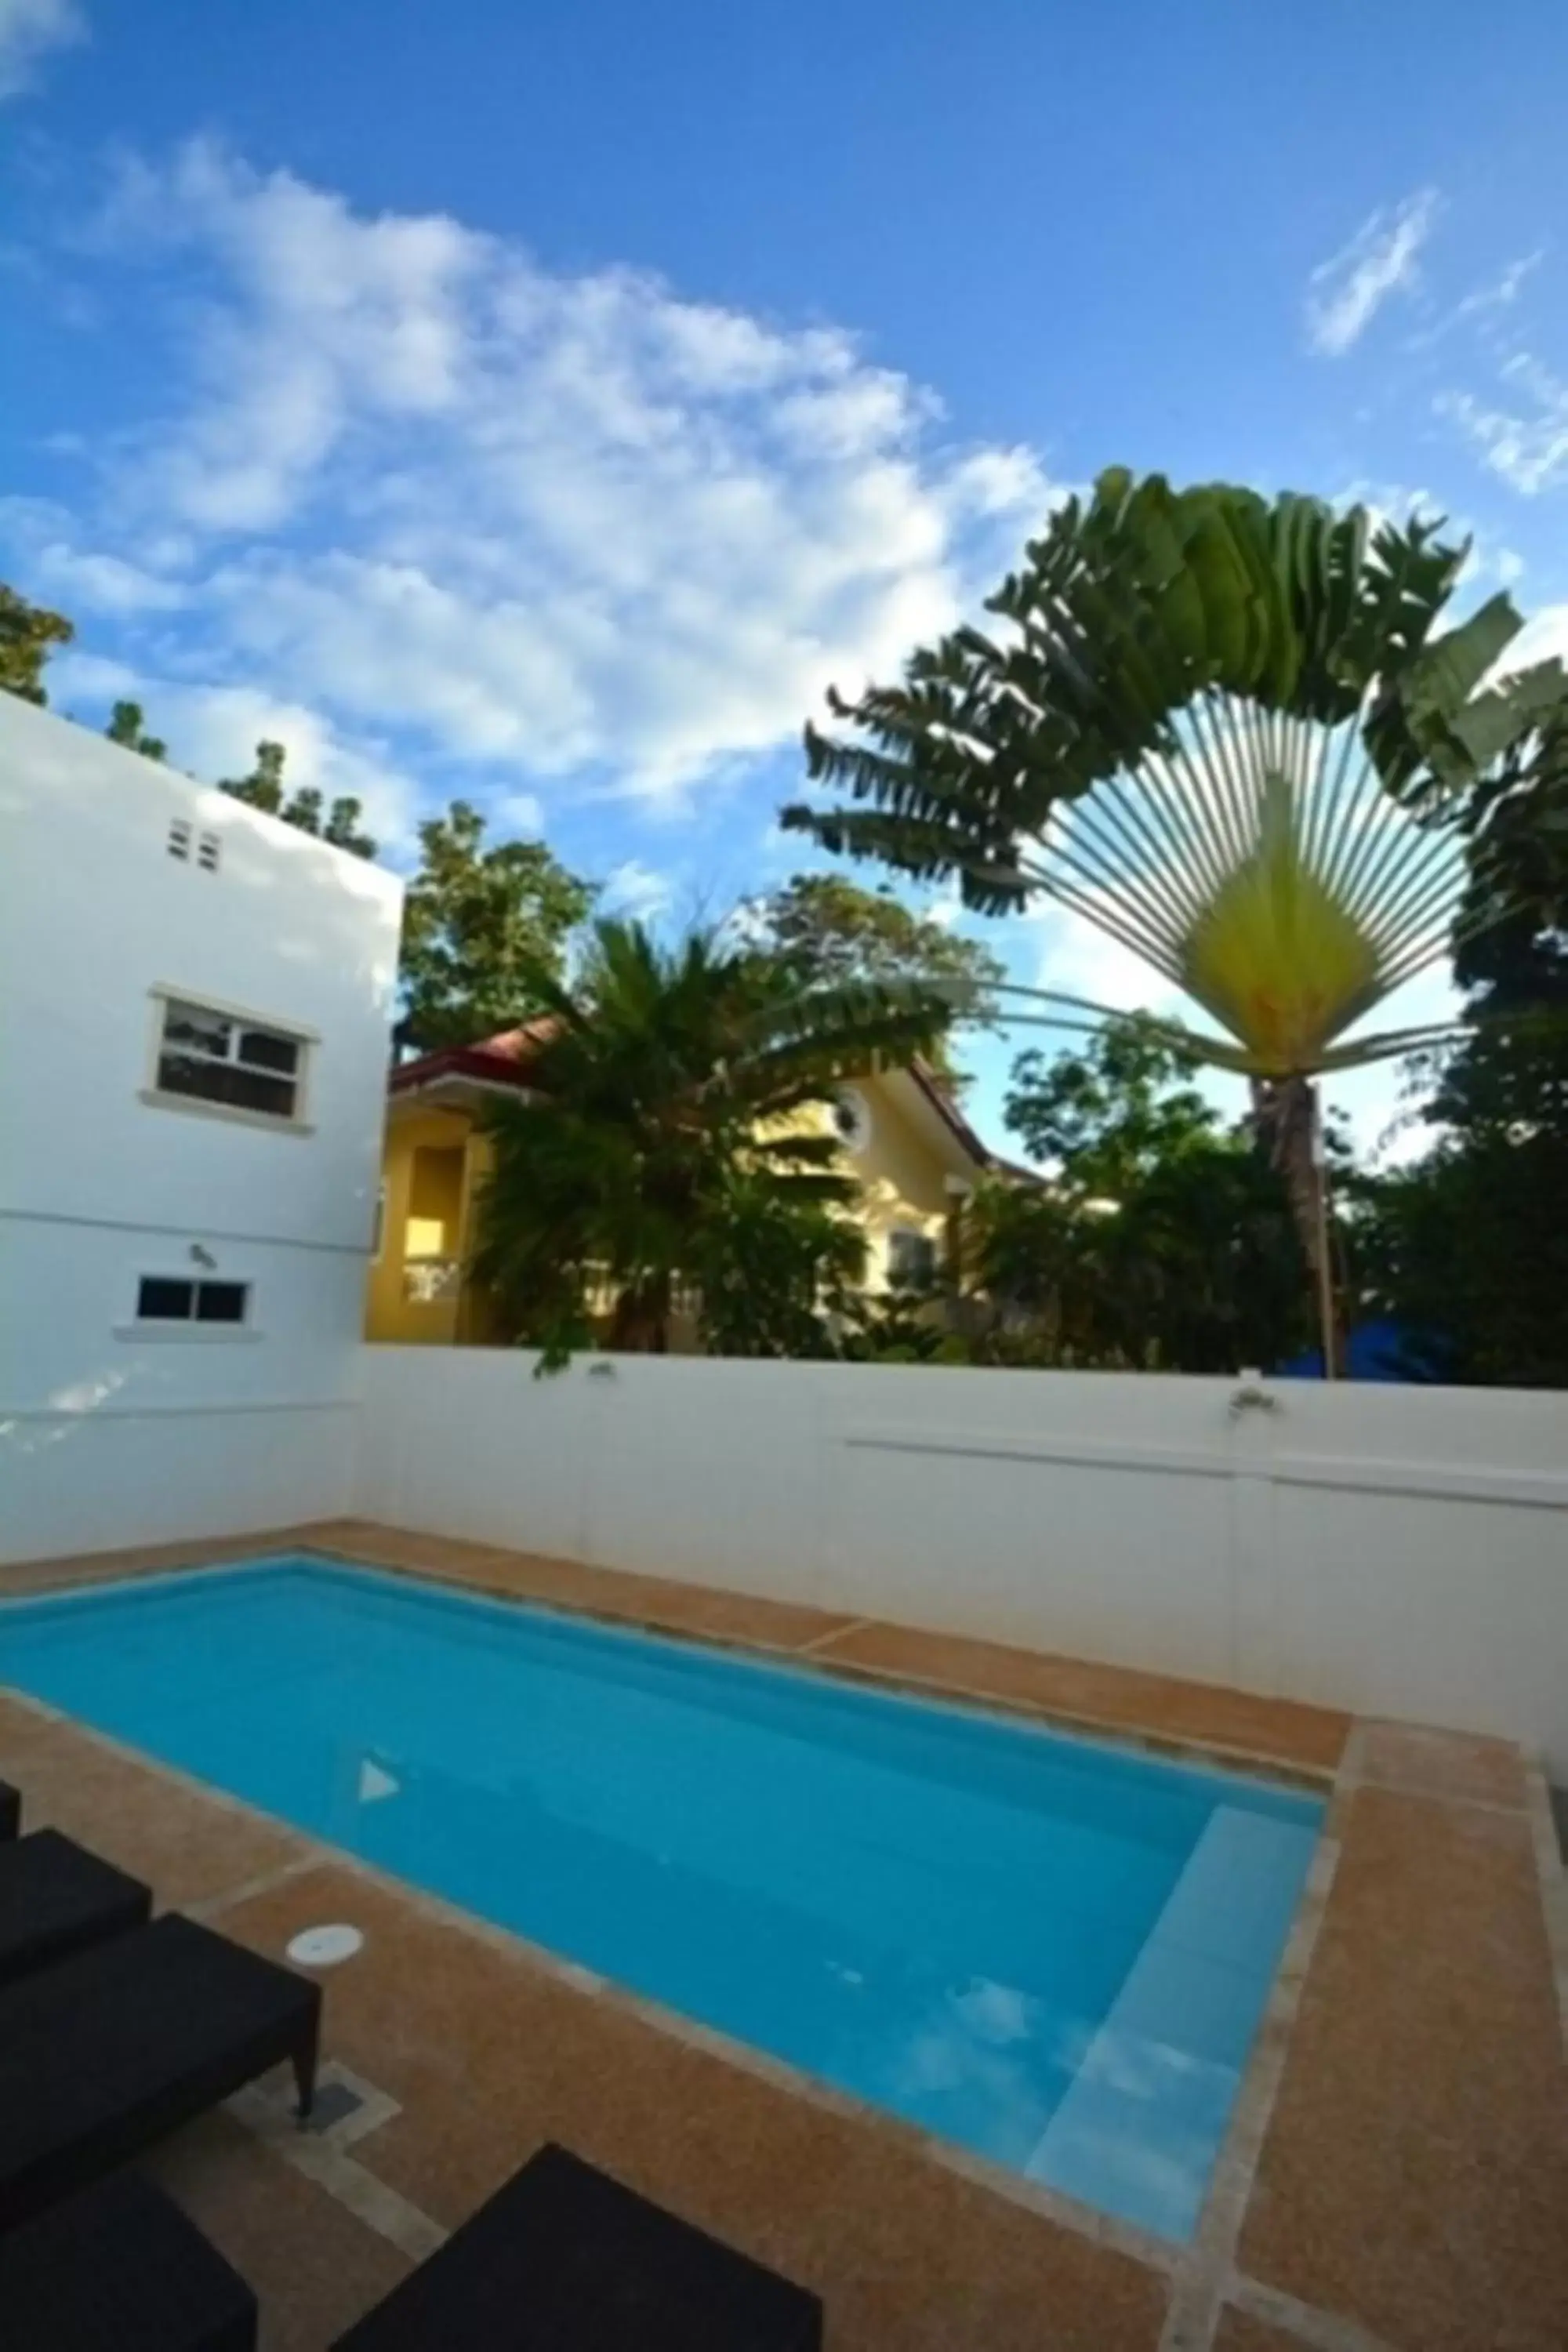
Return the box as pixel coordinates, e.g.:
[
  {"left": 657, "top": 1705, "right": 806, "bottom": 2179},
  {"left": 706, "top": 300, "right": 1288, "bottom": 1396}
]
[{"left": 24, "top": 143, "right": 1053, "bottom": 807}]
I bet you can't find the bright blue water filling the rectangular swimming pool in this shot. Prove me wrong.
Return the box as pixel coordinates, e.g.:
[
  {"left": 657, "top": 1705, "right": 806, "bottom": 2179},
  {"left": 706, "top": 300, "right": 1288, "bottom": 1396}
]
[{"left": 0, "top": 1559, "right": 1321, "bottom": 2239}]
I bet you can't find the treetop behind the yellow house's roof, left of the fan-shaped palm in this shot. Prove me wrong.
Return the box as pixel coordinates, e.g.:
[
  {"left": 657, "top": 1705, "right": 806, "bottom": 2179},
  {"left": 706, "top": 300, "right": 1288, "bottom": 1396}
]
[{"left": 750, "top": 873, "right": 1006, "bottom": 1077}]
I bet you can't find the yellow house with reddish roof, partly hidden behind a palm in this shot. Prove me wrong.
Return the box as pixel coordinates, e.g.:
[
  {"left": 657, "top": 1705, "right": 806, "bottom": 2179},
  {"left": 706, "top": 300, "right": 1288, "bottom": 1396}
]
[{"left": 365, "top": 1030, "right": 999, "bottom": 1345}]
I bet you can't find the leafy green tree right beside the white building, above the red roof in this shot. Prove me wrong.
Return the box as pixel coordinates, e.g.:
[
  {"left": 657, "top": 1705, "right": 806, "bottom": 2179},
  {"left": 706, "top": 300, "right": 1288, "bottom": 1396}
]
[{"left": 402, "top": 800, "right": 595, "bottom": 1054}]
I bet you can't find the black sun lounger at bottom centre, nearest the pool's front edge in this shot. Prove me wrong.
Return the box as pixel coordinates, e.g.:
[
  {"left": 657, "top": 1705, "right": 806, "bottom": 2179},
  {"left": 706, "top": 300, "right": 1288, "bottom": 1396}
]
[{"left": 336, "top": 2145, "right": 822, "bottom": 2352}]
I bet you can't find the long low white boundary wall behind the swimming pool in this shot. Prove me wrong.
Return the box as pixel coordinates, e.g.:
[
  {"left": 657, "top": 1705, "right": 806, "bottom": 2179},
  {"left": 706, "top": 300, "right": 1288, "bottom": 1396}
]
[{"left": 358, "top": 1348, "right": 1568, "bottom": 1776}]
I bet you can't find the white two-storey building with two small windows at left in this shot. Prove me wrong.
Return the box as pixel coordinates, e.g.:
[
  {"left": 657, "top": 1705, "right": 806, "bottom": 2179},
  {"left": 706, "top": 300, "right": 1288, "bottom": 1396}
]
[{"left": 0, "top": 691, "right": 402, "bottom": 1559}]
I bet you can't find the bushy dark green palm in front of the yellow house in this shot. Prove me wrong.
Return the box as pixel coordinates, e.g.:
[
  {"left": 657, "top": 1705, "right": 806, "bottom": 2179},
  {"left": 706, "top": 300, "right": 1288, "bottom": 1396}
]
[{"left": 475, "top": 920, "right": 949, "bottom": 1367}]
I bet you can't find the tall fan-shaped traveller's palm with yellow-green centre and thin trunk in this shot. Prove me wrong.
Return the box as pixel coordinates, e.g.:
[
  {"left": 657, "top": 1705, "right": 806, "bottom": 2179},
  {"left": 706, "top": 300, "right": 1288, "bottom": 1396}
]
[{"left": 785, "top": 470, "right": 1568, "bottom": 1369}]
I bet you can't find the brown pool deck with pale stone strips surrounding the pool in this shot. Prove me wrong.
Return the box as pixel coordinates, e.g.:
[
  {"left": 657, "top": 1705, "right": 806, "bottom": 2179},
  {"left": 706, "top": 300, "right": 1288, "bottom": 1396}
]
[{"left": 0, "top": 1522, "right": 1568, "bottom": 2352}]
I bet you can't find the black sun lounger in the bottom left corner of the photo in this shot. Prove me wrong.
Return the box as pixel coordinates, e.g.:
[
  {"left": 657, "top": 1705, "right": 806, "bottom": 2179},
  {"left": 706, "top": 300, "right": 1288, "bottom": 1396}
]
[{"left": 0, "top": 2173, "right": 256, "bottom": 2352}]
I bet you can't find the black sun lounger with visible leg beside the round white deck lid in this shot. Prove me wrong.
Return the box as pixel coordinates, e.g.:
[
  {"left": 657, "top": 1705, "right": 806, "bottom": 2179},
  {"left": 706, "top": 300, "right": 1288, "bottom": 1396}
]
[{"left": 0, "top": 1912, "right": 322, "bottom": 2230}]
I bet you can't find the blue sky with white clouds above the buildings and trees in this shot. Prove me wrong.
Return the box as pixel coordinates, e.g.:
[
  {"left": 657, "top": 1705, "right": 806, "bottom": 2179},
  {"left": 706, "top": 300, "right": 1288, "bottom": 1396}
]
[{"left": 0, "top": 0, "right": 1568, "bottom": 1148}]
